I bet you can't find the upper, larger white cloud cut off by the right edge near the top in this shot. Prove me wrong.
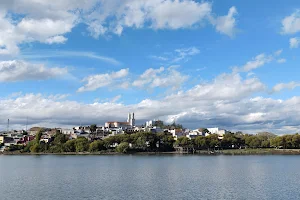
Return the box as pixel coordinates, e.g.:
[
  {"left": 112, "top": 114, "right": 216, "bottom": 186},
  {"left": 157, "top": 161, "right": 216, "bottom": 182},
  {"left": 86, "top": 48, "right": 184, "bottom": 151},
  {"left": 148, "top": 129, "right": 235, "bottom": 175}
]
[{"left": 281, "top": 10, "right": 300, "bottom": 34}]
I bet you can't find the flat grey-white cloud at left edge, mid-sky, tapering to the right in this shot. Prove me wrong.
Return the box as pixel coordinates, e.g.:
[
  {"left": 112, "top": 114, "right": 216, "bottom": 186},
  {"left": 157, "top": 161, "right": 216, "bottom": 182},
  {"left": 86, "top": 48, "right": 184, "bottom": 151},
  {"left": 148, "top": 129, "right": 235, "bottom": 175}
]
[{"left": 0, "top": 60, "right": 68, "bottom": 82}]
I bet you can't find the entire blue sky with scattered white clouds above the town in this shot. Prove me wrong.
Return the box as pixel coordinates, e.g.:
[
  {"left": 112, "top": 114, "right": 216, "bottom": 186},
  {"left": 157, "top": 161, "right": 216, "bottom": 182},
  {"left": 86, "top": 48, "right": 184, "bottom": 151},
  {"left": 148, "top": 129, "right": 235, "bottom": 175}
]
[{"left": 0, "top": 0, "right": 300, "bottom": 134}]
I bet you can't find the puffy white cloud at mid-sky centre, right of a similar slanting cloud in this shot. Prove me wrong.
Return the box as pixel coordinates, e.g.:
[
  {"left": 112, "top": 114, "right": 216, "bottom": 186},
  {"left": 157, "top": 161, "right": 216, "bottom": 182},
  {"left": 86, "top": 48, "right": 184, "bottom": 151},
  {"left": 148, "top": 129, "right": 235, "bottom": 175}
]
[{"left": 132, "top": 67, "right": 188, "bottom": 90}]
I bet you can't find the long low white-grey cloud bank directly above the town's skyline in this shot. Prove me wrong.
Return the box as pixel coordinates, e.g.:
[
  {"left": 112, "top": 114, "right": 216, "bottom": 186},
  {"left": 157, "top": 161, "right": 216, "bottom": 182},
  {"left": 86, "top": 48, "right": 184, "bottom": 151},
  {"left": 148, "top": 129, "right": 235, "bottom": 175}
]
[{"left": 0, "top": 74, "right": 300, "bottom": 133}]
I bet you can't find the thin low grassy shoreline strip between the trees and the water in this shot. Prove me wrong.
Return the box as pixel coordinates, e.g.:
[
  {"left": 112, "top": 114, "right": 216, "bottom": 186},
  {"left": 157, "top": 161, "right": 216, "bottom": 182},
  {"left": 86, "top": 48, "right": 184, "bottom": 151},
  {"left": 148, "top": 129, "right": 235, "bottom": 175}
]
[{"left": 0, "top": 149, "right": 300, "bottom": 156}]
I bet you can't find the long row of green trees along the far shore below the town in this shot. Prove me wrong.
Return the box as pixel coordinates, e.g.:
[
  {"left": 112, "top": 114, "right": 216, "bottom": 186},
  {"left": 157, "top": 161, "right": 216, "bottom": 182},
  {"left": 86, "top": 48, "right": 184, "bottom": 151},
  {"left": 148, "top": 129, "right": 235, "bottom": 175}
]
[{"left": 9, "top": 131, "right": 300, "bottom": 153}]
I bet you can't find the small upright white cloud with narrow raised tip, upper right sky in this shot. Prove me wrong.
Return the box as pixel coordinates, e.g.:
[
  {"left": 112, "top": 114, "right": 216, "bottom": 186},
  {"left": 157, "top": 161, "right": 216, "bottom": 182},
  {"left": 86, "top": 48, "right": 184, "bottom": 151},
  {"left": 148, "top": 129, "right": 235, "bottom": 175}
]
[{"left": 215, "top": 6, "right": 238, "bottom": 37}]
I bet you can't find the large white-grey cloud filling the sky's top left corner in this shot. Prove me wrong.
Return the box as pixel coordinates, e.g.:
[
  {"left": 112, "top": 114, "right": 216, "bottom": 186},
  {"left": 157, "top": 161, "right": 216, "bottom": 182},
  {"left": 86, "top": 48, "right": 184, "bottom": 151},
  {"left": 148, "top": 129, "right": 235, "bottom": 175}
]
[{"left": 0, "top": 0, "right": 91, "bottom": 55}]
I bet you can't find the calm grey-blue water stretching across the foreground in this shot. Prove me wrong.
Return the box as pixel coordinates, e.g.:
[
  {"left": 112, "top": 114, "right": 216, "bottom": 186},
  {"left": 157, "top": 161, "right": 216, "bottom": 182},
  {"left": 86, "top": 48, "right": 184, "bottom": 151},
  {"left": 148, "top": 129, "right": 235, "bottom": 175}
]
[{"left": 0, "top": 155, "right": 300, "bottom": 200}]
